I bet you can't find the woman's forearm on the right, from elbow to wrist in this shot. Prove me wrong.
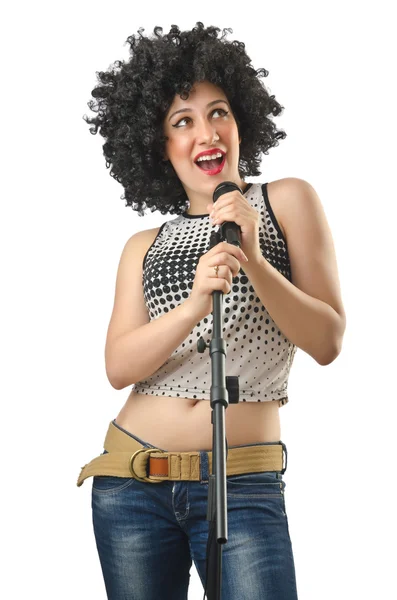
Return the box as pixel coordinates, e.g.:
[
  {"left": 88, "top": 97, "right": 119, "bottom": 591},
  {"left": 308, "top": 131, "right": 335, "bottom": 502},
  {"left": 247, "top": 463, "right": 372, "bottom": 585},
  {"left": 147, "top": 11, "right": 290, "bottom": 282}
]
[{"left": 244, "top": 257, "right": 344, "bottom": 365}]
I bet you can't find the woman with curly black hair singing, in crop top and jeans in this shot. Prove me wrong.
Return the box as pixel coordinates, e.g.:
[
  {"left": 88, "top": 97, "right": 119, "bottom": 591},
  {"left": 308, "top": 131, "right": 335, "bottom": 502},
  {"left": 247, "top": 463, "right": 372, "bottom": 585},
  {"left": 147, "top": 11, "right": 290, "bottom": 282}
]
[{"left": 78, "top": 23, "right": 345, "bottom": 600}]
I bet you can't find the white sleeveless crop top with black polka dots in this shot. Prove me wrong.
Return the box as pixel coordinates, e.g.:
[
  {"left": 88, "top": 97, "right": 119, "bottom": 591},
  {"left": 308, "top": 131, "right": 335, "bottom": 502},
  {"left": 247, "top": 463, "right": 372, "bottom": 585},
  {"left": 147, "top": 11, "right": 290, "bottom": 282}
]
[{"left": 134, "top": 183, "right": 297, "bottom": 406}]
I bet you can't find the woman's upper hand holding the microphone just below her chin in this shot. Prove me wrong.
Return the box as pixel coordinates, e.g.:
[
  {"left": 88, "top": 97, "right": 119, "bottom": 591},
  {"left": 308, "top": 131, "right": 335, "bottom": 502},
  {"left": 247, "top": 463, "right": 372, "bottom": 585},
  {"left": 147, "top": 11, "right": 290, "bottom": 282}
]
[{"left": 207, "top": 190, "right": 262, "bottom": 262}]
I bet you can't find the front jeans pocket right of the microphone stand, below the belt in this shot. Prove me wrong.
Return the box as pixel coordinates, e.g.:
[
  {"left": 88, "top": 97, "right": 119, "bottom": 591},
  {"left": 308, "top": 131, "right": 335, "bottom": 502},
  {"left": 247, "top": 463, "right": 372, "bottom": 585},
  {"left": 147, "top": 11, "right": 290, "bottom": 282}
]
[{"left": 227, "top": 471, "right": 285, "bottom": 501}]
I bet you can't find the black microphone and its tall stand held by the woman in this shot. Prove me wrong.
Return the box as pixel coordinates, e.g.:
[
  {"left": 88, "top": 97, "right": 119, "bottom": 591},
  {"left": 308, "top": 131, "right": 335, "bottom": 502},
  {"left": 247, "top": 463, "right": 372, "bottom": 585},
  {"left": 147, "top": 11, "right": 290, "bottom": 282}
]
[{"left": 197, "top": 181, "right": 242, "bottom": 600}]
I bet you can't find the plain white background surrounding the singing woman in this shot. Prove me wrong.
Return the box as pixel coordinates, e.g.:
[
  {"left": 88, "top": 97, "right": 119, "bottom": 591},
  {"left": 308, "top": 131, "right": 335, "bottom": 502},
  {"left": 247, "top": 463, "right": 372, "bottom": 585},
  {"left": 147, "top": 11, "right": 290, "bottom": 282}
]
[{"left": 0, "top": 0, "right": 397, "bottom": 600}]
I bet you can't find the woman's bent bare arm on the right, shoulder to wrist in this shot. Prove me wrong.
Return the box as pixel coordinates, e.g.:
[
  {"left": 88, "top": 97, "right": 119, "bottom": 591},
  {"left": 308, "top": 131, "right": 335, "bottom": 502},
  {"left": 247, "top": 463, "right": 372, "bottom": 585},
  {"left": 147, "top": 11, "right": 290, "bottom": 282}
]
[{"left": 244, "top": 177, "right": 346, "bottom": 365}]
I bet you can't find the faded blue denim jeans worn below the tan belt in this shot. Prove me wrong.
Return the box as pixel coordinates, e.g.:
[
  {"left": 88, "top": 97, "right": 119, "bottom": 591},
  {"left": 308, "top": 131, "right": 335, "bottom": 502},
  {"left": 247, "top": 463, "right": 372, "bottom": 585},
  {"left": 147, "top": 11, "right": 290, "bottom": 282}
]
[{"left": 92, "top": 423, "right": 298, "bottom": 600}]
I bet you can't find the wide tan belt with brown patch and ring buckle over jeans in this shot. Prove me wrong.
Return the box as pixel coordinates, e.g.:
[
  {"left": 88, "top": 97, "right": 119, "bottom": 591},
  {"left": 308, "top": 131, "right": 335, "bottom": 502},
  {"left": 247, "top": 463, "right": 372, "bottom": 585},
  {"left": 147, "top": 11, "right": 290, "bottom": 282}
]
[{"left": 77, "top": 422, "right": 287, "bottom": 487}]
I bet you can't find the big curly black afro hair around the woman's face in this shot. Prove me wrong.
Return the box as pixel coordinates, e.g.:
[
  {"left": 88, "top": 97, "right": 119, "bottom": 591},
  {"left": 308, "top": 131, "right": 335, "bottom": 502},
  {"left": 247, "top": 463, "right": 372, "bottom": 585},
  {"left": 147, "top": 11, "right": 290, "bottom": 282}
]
[{"left": 83, "top": 22, "right": 287, "bottom": 216}]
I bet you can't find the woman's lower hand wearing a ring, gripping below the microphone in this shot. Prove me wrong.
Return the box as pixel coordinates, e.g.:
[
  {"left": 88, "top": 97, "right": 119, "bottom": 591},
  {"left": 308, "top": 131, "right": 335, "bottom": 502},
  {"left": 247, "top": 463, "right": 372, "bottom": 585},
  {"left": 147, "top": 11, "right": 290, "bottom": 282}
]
[{"left": 186, "top": 242, "right": 248, "bottom": 321}]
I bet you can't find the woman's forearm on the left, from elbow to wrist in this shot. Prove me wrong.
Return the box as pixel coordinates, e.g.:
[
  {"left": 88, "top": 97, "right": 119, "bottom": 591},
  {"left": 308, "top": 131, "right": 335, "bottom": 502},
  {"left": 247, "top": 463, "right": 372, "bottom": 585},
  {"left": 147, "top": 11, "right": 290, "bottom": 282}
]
[{"left": 105, "top": 300, "right": 198, "bottom": 390}]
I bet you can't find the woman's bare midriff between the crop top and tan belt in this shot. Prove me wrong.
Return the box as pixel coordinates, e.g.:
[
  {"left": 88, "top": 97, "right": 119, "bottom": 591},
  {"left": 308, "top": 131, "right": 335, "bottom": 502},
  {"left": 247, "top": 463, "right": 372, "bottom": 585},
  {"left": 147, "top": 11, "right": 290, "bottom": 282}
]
[{"left": 115, "top": 390, "right": 281, "bottom": 452}]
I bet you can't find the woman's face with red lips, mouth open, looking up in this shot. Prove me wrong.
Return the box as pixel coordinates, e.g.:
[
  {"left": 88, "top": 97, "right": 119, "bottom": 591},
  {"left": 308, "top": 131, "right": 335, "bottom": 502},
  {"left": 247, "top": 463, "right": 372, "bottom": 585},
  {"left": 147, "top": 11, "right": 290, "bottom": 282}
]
[{"left": 164, "top": 81, "right": 243, "bottom": 196}]
